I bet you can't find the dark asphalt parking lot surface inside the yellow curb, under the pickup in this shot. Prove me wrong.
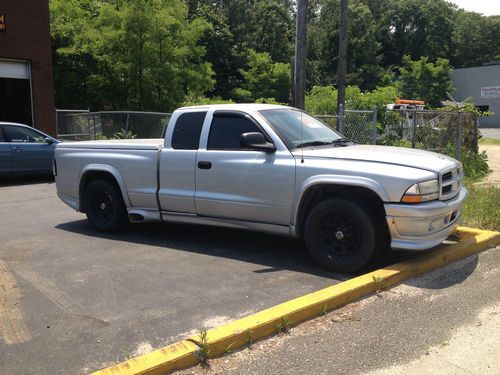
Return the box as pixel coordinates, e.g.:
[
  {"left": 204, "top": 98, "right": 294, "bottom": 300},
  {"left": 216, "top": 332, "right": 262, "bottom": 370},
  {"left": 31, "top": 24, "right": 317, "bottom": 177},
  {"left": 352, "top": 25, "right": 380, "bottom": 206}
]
[{"left": 0, "top": 179, "right": 414, "bottom": 374}]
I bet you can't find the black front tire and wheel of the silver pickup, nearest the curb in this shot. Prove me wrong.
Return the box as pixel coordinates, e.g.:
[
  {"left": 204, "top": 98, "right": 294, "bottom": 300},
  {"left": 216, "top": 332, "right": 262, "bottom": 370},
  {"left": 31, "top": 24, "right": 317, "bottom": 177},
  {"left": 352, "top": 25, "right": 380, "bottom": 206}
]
[{"left": 304, "top": 199, "right": 379, "bottom": 273}]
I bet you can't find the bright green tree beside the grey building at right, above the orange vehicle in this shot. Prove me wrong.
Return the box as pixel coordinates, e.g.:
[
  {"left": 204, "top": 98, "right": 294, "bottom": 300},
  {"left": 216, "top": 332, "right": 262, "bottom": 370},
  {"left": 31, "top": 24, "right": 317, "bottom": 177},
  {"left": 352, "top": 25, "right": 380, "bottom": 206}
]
[{"left": 398, "top": 56, "right": 453, "bottom": 106}]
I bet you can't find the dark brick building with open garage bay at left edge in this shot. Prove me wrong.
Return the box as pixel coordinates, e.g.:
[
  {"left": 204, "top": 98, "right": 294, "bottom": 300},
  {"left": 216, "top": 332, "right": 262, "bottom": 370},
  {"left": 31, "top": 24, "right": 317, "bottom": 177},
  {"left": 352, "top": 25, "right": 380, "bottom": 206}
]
[{"left": 0, "top": 0, "right": 56, "bottom": 135}]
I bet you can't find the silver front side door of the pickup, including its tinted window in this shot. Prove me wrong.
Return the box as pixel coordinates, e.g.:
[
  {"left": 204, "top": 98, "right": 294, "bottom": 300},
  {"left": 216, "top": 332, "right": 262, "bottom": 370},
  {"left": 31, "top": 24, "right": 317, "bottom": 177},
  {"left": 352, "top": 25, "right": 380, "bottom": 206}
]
[{"left": 195, "top": 111, "right": 295, "bottom": 225}]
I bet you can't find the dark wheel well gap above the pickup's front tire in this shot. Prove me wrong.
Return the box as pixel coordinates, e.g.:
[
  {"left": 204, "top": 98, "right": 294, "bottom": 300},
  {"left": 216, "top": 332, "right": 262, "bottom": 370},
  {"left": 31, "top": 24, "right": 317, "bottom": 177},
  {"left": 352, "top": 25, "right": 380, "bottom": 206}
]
[{"left": 296, "top": 184, "right": 387, "bottom": 237}]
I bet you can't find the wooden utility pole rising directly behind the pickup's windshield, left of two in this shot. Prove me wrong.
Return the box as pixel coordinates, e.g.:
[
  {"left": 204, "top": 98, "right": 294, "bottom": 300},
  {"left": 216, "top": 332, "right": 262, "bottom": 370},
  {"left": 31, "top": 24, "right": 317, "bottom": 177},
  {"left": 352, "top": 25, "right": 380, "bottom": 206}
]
[{"left": 293, "top": 0, "right": 308, "bottom": 109}]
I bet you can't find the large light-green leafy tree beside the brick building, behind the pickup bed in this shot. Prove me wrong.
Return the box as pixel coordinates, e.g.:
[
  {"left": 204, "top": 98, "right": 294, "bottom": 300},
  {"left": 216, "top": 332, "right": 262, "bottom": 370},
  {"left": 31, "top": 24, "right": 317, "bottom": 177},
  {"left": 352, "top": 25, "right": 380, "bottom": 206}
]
[{"left": 51, "top": 0, "right": 214, "bottom": 111}]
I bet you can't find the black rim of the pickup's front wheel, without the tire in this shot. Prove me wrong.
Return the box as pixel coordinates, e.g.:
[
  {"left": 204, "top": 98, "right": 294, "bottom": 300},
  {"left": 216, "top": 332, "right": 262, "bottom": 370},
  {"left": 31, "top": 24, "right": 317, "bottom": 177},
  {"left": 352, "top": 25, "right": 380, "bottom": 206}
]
[{"left": 317, "top": 214, "right": 363, "bottom": 260}]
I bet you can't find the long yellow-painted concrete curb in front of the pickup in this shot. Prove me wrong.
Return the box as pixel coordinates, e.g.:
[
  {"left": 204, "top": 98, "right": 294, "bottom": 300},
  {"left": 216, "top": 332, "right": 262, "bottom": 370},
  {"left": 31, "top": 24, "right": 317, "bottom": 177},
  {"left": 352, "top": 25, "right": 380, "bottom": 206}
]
[{"left": 94, "top": 227, "right": 500, "bottom": 375}]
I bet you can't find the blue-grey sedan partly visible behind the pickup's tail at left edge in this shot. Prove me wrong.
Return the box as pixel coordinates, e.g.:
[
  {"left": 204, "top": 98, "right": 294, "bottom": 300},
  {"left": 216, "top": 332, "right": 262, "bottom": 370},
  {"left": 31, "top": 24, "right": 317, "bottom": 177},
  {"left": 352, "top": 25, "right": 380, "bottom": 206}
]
[{"left": 0, "top": 122, "right": 59, "bottom": 175}]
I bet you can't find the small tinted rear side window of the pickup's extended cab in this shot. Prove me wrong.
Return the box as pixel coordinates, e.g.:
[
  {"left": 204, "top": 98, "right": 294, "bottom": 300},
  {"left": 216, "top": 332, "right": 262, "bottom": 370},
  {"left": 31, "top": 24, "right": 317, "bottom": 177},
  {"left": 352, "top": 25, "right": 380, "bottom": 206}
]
[{"left": 172, "top": 112, "right": 207, "bottom": 150}]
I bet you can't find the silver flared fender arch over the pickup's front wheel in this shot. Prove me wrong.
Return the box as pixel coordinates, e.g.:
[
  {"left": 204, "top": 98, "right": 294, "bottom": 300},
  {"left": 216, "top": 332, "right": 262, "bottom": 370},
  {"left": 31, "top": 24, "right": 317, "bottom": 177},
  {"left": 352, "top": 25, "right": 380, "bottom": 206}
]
[{"left": 291, "top": 174, "right": 389, "bottom": 227}]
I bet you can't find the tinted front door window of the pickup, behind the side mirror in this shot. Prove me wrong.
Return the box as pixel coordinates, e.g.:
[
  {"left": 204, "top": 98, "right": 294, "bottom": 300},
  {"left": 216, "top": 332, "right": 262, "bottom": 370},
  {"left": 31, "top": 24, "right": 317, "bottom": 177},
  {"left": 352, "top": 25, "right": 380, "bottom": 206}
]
[{"left": 207, "top": 117, "right": 261, "bottom": 150}]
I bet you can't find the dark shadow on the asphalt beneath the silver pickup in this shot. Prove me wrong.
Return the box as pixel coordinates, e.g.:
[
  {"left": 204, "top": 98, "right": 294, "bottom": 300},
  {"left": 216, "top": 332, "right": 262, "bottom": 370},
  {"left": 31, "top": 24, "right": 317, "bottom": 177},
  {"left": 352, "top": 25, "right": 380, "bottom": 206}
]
[{"left": 56, "top": 220, "right": 414, "bottom": 281}]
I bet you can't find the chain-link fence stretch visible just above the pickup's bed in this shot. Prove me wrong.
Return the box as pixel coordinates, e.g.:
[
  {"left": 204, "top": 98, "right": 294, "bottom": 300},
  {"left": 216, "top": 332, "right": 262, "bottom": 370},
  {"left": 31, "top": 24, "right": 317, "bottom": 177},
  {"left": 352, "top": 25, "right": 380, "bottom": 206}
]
[{"left": 57, "top": 110, "right": 171, "bottom": 141}]
